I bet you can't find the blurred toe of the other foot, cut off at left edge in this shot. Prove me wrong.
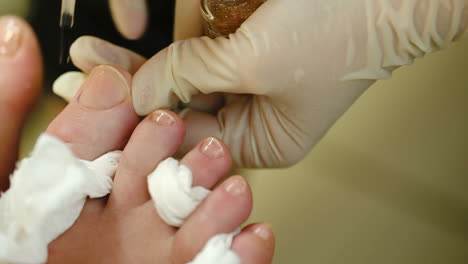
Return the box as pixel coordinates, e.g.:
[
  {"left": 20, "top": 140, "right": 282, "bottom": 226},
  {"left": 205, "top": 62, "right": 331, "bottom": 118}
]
[{"left": 0, "top": 16, "right": 42, "bottom": 190}]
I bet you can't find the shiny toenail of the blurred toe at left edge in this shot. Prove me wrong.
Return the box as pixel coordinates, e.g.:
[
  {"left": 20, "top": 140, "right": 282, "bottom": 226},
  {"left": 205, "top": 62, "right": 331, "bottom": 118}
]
[{"left": 0, "top": 17, "right": 22, "bottom": 56}]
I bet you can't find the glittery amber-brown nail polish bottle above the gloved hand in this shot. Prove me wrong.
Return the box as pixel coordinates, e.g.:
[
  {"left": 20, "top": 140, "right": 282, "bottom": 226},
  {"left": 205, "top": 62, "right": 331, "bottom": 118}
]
[{"left": 201, "top": 0, "right": 267, "bottom": 38}]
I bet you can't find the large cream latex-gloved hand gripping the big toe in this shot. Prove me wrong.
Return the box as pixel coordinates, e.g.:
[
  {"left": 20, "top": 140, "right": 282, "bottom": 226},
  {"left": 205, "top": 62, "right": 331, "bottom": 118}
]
[{"left": 57, "top": 0, "right": 468, "bottom": 167}]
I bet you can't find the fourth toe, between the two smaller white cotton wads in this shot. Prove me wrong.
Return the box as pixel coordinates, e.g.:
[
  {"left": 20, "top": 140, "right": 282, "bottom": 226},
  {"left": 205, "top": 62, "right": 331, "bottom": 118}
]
[{"left": 172, "top": 176, "right": 252, "bottom": 263}]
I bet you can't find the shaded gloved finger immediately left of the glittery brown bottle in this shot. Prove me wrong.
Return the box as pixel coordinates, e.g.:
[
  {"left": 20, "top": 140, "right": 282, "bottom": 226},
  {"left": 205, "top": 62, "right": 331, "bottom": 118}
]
[{"left": 174, "top": 0, "right": 203, "bottom": 41}]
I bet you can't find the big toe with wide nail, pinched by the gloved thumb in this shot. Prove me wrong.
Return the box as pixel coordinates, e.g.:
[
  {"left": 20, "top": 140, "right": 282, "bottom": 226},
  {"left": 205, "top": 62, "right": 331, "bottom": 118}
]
[{"left": 47, "top": 66, "right": 138, "bottom": 160}]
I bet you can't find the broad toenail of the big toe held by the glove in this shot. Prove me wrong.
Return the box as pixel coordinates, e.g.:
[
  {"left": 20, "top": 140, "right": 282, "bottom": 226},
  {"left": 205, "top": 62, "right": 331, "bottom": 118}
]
[{"left": 78, "top": 66, "right": 130, "bottom": 110}]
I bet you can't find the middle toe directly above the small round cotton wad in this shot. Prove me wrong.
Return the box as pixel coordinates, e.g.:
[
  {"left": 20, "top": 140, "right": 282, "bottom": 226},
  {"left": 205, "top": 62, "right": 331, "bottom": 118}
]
[{"left": 181, "top": 137, "right": 231, "bottom": 189}]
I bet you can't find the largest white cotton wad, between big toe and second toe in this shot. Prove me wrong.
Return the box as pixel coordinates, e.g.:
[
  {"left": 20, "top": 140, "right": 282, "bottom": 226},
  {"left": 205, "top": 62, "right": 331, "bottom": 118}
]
[{"left": 0, "top": 134, "right": 121, "bottom": 263}]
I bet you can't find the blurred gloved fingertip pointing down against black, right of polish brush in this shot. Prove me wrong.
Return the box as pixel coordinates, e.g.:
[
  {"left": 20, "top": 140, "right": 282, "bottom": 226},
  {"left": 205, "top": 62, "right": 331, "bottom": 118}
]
[{"left": 109, "top": 0, "right": 148, "bottom": 40}]
